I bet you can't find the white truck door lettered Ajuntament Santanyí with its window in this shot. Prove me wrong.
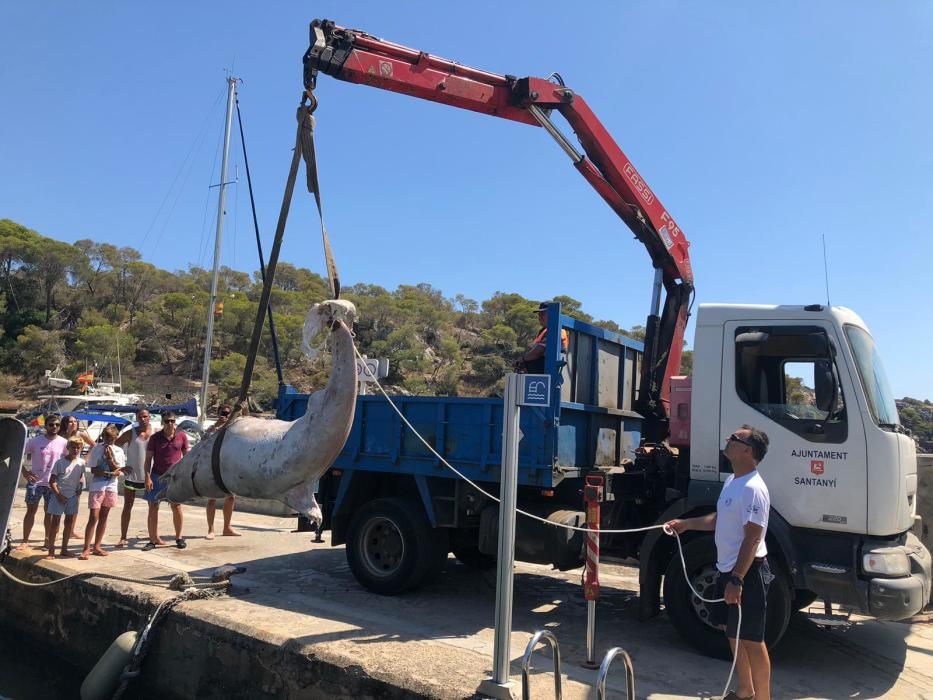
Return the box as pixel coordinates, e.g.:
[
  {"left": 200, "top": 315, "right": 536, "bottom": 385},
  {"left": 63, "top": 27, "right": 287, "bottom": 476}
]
[{"left": 719, "top": 320, "right": 868, "bottom": 532}]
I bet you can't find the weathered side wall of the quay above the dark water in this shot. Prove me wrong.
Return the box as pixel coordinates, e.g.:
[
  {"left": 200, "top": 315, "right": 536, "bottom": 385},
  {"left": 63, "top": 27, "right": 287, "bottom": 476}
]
[{"left": 0, "top": 558, "right": 425, "bottom": 700}]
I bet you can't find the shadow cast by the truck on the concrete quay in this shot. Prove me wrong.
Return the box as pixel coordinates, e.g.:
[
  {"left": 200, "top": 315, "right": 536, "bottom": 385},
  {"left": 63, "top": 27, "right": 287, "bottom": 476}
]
[{"left": 189, "top": 545, "right": 909, "bottom": 698}]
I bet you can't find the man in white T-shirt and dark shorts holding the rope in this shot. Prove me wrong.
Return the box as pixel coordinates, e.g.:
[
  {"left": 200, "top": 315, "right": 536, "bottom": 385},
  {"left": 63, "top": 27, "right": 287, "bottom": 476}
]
[{"left": 668, "top": 425, "right": 773, "bottom": 700}]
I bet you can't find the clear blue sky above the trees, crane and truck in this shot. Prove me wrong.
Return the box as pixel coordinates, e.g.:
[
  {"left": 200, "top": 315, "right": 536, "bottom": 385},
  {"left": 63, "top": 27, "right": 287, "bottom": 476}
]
[{"left": 0, "top": 0, "right": 933, "bottom": 398}]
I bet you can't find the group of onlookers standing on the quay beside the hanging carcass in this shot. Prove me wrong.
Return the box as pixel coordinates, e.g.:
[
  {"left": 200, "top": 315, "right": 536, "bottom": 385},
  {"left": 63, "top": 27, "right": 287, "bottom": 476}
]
[{"left": 19, "top": 404, "right": 239, "bottom": 559}]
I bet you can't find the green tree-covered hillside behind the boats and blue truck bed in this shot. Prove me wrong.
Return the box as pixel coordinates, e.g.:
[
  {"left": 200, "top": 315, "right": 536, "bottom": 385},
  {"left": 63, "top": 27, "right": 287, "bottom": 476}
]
[{"left": 0, "top": 219, "right": 648, "bottom": 407}]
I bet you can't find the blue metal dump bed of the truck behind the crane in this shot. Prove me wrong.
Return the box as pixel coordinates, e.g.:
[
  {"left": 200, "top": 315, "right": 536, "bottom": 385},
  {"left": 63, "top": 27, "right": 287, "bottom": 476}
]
[{"left": 276, "top": 304, "right": 643, "bottom": 488}]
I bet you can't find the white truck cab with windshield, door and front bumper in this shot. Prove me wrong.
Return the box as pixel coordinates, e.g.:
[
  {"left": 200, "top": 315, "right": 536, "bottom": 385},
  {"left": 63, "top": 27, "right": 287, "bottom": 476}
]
[{"left": 688, "top": 304, "right": 931, "bottom": 620}]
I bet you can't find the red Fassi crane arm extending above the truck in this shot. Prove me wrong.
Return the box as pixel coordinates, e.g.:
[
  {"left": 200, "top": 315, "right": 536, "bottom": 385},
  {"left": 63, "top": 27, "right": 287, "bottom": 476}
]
[{"left": 304, "top": 20, "right": 693, "bottom": 432}]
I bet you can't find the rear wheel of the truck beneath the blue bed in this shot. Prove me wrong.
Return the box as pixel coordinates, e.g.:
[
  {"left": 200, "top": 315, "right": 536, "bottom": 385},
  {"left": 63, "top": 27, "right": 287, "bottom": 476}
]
[{"left": 347, "top": 498, "right": 438, "bottom": 595}]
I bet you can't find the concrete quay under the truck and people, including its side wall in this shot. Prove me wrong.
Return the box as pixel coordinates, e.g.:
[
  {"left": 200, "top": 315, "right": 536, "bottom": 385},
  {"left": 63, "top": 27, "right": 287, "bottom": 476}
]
[{"left": 0, "top": 494, "right": 933, "bottom": 700}]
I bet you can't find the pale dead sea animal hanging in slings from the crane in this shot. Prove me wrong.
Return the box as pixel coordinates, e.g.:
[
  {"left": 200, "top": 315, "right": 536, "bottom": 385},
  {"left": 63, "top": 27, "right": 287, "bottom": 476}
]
[{"left": 165, "top": 300, "right": 357, "bottom": 524}]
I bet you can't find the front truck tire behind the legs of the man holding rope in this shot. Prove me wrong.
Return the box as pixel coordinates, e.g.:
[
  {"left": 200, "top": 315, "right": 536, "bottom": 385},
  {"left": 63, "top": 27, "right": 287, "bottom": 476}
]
[{"left": 664, "top": 536, "right": 793, "bottom": 660}]
